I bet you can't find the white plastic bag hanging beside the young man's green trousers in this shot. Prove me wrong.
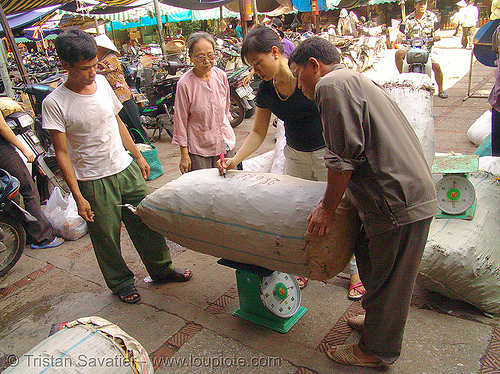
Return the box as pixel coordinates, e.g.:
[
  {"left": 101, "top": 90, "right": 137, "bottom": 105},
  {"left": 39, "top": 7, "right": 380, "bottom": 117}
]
[{"left": 44, "top": 187, "right": 88, "bottom": 240}]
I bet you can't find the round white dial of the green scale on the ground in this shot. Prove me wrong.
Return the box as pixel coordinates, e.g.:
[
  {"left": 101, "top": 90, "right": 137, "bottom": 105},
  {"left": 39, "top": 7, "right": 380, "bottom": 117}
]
[{"left": 260, "top": 271, "right": 300, "bottom": 318}]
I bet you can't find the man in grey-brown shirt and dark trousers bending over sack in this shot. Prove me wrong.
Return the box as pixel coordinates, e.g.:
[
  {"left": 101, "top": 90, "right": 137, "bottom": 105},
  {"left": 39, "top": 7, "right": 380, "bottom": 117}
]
[{"left": 289, "top": 37, "right": 437, "bottom": 367}]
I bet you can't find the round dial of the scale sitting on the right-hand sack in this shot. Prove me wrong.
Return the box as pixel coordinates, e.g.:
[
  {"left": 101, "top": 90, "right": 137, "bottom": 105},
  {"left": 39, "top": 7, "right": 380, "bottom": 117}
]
[{"left": 436, "top": 174, "right": 476, "bottom": 214}]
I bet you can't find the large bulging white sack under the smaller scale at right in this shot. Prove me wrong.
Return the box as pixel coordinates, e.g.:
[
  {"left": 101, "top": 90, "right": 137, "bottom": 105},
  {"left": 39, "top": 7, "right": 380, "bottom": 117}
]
[{"left": 417, "top": 172, "right": 500, "bottom": 314}]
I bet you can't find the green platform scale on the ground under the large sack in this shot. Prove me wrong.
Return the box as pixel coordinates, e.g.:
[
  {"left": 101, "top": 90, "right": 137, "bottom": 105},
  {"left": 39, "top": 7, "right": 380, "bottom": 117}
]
[{"left": 218, "top": 259, "right": 307, "bottom": 333}]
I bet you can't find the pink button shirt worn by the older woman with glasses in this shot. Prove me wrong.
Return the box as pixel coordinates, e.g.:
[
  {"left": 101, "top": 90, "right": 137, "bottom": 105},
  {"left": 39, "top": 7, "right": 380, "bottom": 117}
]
[{"left": 172, "top": 67, "right": 236, "bottom": 157}]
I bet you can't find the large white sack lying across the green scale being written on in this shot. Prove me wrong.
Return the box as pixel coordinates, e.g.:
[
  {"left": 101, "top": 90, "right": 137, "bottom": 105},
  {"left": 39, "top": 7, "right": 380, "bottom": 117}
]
[{"left": 135, "top": 169, "right": 359, "bottom": 279}]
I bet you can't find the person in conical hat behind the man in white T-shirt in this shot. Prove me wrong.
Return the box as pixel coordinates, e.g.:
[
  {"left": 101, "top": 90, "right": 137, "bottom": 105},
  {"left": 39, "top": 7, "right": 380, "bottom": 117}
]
[{"left": 95, "top": 34, "right": 149, "bottom": 143}]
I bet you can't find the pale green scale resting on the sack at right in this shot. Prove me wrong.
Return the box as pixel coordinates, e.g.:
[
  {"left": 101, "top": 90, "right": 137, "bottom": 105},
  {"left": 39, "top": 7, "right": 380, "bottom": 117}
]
[{"left": 431, "top": 155, "right": 479, "bottom": 220}]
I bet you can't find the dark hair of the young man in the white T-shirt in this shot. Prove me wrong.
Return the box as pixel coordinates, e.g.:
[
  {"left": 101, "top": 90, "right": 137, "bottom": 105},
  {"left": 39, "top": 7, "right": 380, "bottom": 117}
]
[{"left": 54, "top": 30, "right": 97, "bottom": 65}]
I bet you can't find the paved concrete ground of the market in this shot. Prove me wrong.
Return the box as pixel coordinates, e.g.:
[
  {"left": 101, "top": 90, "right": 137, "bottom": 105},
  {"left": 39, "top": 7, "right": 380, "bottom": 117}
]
[{"left": 0, "top": 30, "right": 500, "bottom": 374}]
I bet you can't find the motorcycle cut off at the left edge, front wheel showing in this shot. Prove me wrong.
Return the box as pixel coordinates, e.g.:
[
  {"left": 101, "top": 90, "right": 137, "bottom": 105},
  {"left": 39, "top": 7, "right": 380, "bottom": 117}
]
[{"left": 0, "top": 169, "right": 36, "bottom": 277}]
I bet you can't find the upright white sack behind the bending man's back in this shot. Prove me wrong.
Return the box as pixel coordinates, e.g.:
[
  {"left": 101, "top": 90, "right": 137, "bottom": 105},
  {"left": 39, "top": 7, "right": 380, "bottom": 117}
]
[{"left": 371, "top": 73, "right": 435, "bottom": 167}]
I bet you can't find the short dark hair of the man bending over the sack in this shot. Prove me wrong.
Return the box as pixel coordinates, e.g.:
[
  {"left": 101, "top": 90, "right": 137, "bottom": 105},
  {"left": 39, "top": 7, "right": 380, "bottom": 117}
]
[{"left": 288, "top": 36, "right": 341, "bottom": 66}]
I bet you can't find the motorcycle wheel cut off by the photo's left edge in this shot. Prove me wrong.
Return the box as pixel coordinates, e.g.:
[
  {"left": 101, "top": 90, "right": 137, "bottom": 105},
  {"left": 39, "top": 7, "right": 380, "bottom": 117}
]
[{"left": 0, "top": 215, "right": 26, "bottom": 277}]
